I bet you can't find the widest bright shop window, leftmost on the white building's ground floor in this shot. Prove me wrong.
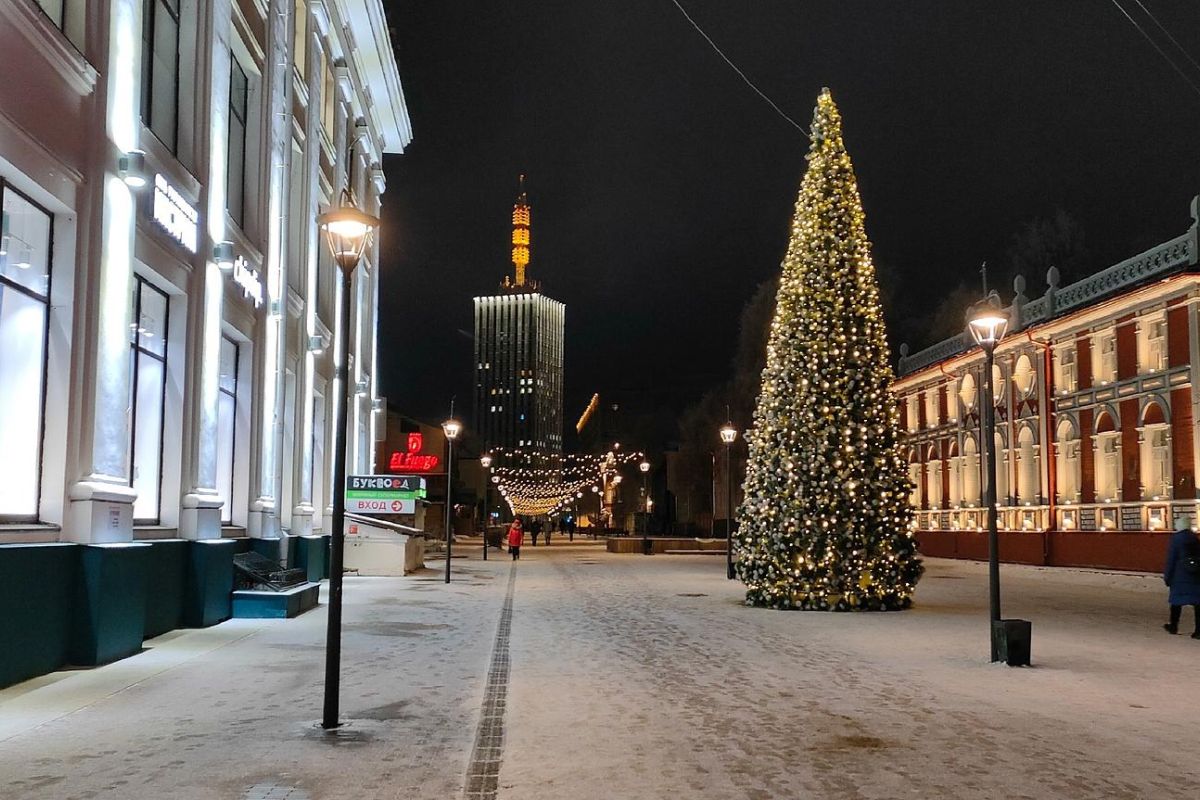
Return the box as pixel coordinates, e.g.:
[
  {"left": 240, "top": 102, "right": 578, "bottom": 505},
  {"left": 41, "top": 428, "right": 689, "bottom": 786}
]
[{"left": 0, "top": 184, "right": 52, "bottom": 521}]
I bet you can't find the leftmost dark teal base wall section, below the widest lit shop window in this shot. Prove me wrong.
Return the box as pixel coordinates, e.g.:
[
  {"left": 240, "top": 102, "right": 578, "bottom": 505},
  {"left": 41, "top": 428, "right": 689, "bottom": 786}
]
[{"left": 0, "top": 545, "right": 80, "bottom": 687}]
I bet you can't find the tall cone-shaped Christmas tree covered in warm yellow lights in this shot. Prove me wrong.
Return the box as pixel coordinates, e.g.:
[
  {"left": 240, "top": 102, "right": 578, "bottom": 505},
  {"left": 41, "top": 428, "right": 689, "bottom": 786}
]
[{"left": 734, "top": 90, "right": 922, "bottom": 610}]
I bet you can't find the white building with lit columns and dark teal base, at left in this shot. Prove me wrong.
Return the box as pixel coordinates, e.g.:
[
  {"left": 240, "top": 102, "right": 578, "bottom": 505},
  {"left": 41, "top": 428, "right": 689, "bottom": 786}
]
[{"left": 0, "top": 0, "right": 412, "bottom": 685}]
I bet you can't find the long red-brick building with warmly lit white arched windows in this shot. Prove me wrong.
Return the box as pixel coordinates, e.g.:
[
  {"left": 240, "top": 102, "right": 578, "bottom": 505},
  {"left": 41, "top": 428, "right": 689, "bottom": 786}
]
[{"left": 895, "top": 198, "right": 1200, "bottom": 571}]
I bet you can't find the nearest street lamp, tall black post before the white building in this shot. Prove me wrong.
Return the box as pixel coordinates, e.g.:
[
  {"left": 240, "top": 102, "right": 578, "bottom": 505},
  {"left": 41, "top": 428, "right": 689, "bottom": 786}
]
[{"left": 317, "top": 191, "right": 379, "bottom": 729}]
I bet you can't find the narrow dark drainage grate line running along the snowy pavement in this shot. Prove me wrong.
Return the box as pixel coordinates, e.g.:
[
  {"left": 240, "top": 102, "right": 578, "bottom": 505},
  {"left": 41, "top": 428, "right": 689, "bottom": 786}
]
[{"left": 462, "top": 561, "right": 517, "bottom": 800}]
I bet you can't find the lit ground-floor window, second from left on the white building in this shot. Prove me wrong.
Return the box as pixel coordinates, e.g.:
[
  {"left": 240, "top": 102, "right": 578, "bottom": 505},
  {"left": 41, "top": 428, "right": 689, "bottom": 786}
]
[{"left": 130, "top": 277, "right": 167, "bottom": 524}]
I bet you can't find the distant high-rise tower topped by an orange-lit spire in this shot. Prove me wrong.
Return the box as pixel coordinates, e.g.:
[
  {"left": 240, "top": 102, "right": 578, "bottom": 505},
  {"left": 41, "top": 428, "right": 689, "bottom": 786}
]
[{"left": 474, "top": 182, "right": 566, "bottom": 453}]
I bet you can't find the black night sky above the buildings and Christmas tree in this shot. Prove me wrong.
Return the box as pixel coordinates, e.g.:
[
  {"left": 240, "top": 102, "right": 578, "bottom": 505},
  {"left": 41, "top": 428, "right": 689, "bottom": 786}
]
[{"left": 379, "top": 0, "right": 1200, "bottom": 431}]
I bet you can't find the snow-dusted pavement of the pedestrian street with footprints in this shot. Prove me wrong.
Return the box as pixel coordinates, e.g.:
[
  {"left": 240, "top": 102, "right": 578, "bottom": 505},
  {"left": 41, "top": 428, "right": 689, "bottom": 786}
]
[{"left": 0, "top": 542, "right": 1200, "bottom": 800}]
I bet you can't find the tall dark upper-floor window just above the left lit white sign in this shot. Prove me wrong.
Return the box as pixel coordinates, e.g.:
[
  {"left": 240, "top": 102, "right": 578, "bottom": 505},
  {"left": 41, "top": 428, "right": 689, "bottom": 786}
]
[{"left": 142, "top": 0, "right": 179, "bottom": 152}]
